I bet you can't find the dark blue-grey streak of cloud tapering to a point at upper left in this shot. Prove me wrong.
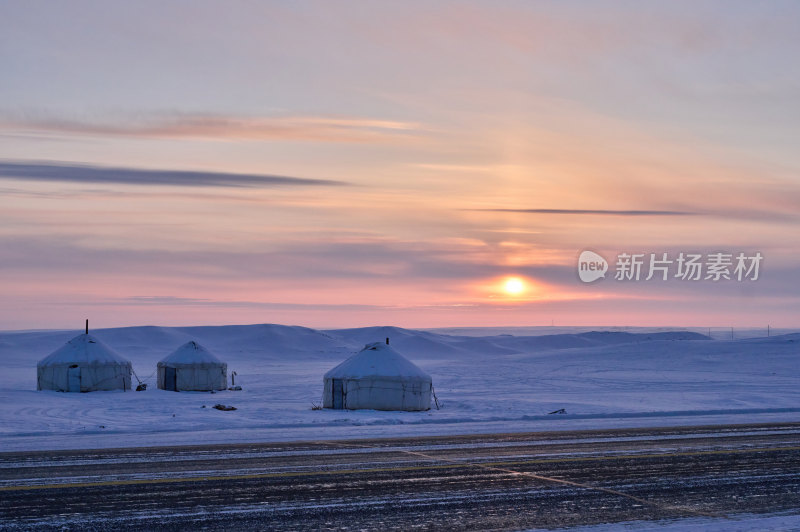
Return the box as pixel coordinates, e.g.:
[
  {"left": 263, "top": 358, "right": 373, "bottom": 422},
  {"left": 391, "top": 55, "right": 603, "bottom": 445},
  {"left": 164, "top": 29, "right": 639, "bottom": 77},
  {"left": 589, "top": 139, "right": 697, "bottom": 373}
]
[{"left": 0, "top": 161, "right": 347, "bottom": 187}]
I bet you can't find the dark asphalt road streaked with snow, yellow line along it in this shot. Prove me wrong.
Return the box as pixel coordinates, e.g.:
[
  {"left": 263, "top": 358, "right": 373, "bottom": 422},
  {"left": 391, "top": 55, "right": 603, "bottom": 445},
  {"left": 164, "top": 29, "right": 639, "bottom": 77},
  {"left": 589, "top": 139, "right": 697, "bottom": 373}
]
[{"left": 0, "top": 423, "right": 800, "bottom": 530}]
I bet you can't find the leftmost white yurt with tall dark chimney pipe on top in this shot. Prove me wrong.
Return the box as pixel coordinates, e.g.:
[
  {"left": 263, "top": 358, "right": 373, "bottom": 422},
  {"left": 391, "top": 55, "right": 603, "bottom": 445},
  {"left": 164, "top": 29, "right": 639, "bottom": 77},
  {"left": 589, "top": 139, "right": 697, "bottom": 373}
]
[{"left": 36, "top": 333, "right": 131, "bottom": 392}]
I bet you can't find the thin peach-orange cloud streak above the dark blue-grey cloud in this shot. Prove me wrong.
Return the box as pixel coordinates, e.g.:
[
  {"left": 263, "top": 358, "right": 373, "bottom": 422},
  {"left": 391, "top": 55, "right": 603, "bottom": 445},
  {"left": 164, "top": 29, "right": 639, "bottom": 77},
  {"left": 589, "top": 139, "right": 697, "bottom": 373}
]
[{"left": 0, "top": 112, "right": 420, "bottom": 142}]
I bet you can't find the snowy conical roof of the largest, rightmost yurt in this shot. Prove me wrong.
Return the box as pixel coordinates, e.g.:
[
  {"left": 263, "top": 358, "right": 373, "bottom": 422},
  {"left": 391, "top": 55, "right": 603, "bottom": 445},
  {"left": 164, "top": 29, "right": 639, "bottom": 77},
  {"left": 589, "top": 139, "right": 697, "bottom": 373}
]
[{"left": 325, "top": 342, "right": 431, "bottom": 380}]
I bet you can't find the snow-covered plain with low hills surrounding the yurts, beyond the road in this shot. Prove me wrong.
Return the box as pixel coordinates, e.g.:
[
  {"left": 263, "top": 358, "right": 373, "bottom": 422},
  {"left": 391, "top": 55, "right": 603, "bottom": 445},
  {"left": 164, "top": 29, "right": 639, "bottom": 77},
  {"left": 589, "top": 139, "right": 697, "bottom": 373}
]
[{"left": 0, "top": 325, "right": 800, "bottom": 450}]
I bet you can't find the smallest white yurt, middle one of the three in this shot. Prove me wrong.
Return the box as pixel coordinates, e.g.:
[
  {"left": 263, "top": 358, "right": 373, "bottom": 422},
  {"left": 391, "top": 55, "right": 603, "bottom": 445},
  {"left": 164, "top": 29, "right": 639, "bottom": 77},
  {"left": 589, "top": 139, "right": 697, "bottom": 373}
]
[{"left": 158, "top": 340, "right": 228, "bottom": 392}]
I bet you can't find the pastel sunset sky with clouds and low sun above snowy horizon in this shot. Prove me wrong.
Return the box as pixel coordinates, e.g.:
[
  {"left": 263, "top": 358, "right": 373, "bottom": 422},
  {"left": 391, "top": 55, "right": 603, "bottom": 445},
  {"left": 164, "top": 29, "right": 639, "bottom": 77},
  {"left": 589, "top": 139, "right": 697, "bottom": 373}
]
[{"left": 0, "top": 0, "right": 800, "bottom": 329}]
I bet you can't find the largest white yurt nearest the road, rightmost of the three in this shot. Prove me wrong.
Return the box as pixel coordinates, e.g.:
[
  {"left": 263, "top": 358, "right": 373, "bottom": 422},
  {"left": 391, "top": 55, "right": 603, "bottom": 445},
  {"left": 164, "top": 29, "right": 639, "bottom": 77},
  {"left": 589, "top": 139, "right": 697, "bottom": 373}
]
[{"left": 322, "top": 340, "right": 433, "bottom": 410}]
